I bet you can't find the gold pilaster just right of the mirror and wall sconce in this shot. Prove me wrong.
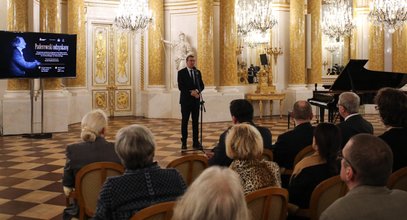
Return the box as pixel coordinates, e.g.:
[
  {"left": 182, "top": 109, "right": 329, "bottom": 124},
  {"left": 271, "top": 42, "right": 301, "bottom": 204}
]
[{"left": 289, "top": 0, "right": 305, "bottom": 84}]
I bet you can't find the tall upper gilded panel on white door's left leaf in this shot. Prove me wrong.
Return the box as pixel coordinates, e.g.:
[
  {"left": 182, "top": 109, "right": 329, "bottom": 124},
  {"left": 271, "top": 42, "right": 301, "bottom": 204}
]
[{"left": 92, "top": 26, "right": 109, "bottom": 86}]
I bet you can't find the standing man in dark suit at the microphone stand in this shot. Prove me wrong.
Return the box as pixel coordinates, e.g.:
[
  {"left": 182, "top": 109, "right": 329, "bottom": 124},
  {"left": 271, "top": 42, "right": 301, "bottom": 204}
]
[{"left": 178, "top": 55, "right": 205, "bottom": 149}]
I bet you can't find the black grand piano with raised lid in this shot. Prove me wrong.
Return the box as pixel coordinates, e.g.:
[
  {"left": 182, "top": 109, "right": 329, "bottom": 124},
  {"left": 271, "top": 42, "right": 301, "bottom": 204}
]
[{"left": 308, "top": 59, "right": 407, "bottom": 122}]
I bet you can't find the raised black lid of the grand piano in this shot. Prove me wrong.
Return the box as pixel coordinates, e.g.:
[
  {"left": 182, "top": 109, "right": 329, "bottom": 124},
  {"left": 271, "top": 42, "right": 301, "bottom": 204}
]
[{"left": 330, "top": 59, "right": 407, "bottom": 91}]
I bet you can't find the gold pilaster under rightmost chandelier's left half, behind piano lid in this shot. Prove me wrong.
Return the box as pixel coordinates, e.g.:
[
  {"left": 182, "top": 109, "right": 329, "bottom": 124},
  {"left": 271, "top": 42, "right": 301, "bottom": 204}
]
[{"left": 368, "top": 25, "right": 384, "bottom": 71}]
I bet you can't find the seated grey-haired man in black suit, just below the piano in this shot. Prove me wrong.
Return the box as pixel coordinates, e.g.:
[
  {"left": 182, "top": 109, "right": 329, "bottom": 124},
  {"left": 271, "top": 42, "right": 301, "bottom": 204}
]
[{"left": 338, "top": 92, "right": 373, "bottom": 147}]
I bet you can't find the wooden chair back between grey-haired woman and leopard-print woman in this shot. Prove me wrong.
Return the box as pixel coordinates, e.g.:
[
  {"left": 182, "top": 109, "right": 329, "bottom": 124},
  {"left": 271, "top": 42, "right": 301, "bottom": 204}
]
[{"left": 167, "top": 154, "right": 208, "bottom": 186}]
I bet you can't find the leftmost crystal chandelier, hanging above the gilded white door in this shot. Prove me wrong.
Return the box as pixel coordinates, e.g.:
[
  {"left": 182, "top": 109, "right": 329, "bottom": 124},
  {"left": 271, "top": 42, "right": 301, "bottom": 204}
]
[{"left": 114, "top": 0, "right": 153, "bottom": 32}]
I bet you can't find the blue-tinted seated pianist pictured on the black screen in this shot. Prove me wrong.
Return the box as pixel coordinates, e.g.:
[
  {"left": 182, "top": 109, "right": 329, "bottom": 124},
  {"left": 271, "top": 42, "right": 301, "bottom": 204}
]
[{"left": 9, "top": 36, "right": 40, "bottom": 76}]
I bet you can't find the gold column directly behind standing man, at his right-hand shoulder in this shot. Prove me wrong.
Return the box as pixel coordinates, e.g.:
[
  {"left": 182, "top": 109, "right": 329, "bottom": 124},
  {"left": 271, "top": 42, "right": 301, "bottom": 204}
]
[{"left": 197, "top": 0, "right": 215, "bottom": 86}]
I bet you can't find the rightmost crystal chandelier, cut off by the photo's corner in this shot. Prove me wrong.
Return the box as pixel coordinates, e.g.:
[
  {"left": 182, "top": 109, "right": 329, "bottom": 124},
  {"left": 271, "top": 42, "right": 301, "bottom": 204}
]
[{"left": 369, "top": 0, "right": 407, "bottom": 33}]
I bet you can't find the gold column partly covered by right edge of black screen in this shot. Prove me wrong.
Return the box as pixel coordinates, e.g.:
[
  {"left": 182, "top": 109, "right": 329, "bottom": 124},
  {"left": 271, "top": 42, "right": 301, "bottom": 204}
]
[{"left": 67, "top": 0, "right": 86, "bottom": 87}]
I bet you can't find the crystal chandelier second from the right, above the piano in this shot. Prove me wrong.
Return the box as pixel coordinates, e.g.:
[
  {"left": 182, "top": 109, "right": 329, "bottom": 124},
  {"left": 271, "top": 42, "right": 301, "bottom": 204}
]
[{"left": 321, "top": 0, "right": 355, "bottom": 39}]
